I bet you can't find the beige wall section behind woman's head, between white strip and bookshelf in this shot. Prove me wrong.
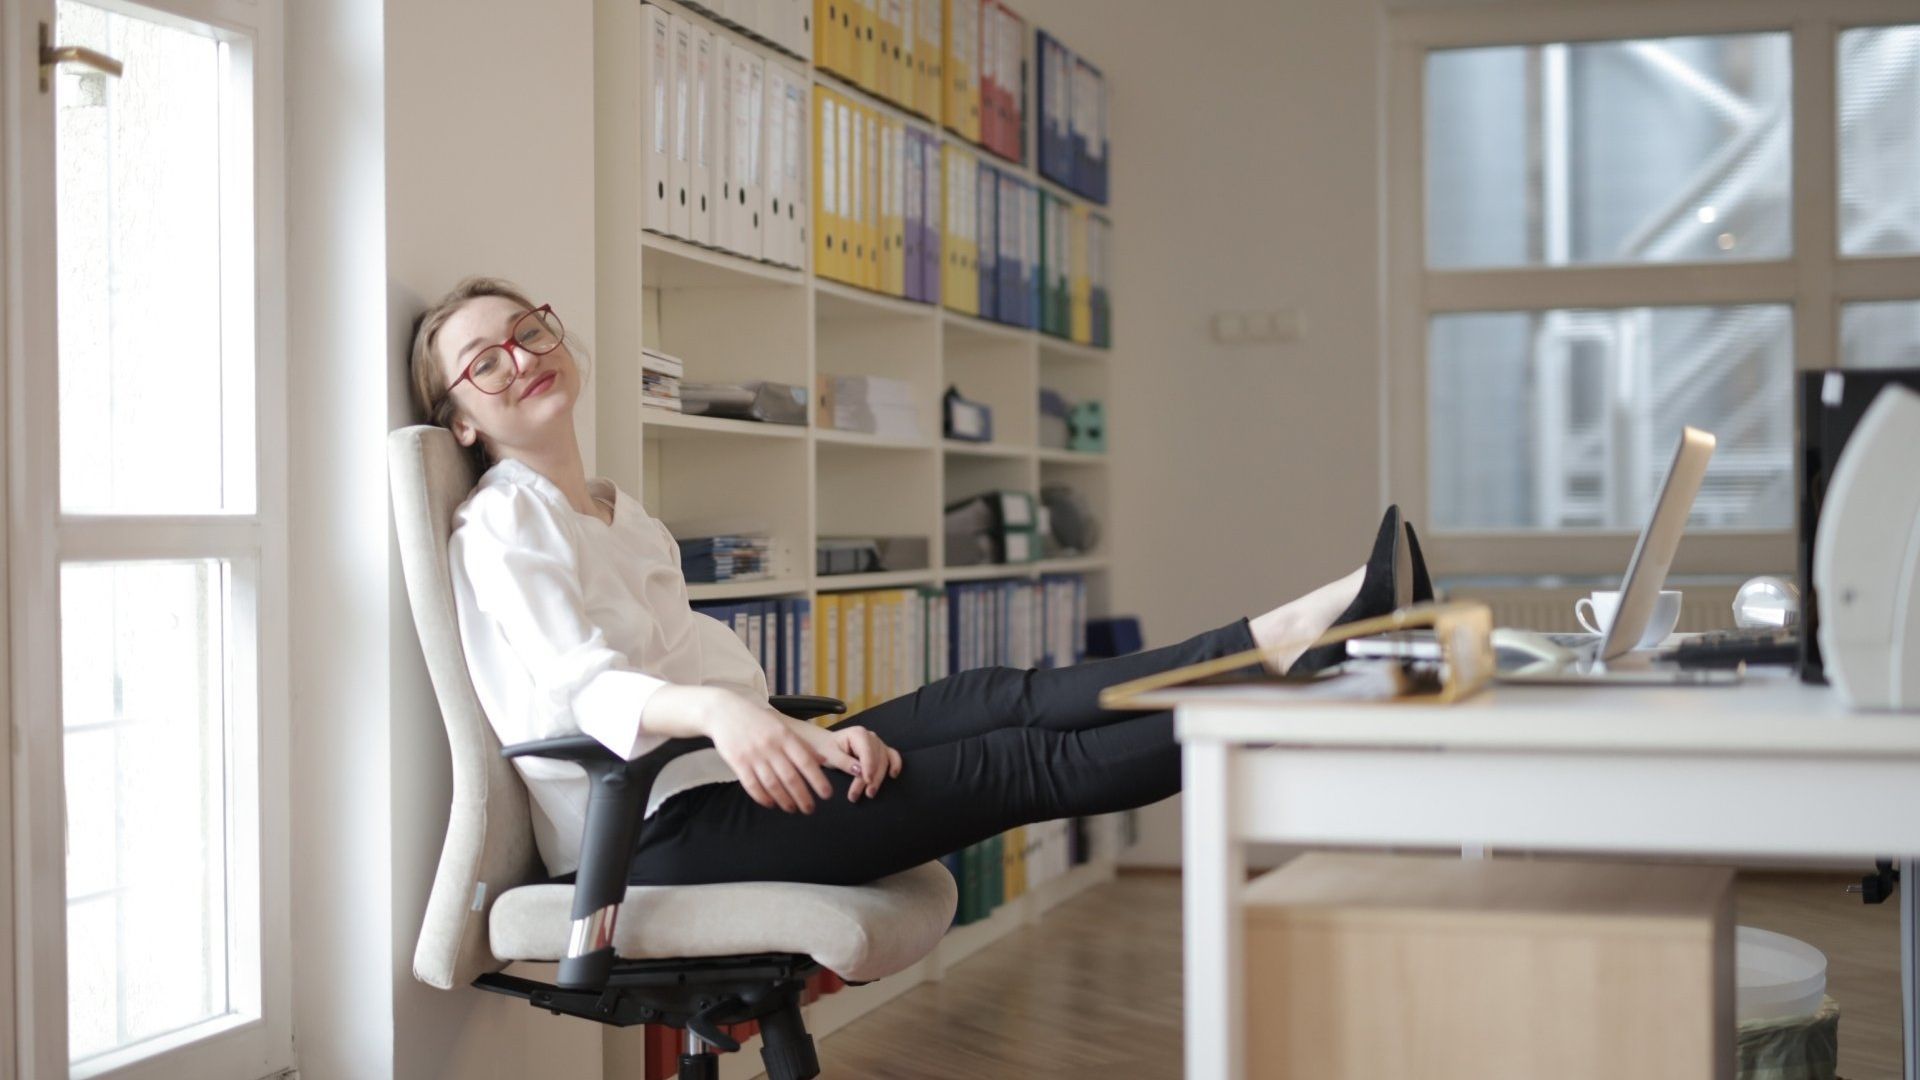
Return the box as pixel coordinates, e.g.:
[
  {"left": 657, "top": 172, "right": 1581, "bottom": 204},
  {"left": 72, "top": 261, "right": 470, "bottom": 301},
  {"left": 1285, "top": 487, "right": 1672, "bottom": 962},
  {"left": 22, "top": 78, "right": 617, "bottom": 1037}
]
[{"left": 384, "top": 0, "right": 599, "bottom": 1080}]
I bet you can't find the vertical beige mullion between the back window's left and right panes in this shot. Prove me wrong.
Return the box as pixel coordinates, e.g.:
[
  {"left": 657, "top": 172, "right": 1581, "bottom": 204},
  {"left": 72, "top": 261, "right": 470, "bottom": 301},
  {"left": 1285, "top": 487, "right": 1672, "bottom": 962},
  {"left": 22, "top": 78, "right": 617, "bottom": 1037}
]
[{"left": 1793, "top": 17, "right": 1839, "bottom": 369}]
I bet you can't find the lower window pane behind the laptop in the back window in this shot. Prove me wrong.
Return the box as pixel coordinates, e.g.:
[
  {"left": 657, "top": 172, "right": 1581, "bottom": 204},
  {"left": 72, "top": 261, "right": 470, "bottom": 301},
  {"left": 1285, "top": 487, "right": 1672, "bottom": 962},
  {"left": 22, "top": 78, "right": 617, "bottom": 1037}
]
[{"left": 1427, "top": 306, "right": 1793, "bottom": 530}]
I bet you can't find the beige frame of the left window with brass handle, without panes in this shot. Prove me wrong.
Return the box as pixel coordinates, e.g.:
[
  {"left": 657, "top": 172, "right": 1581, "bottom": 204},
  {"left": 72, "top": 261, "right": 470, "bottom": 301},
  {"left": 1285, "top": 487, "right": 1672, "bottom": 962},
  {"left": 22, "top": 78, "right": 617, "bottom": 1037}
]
[{"left": 0, "top": 0, "right": 294, "bottom": 1080}]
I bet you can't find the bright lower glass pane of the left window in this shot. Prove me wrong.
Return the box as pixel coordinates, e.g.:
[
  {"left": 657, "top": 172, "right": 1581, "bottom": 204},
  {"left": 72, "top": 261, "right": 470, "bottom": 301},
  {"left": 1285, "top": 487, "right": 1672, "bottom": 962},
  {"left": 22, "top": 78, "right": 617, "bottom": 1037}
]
[{"left": 60, "top": 559, "right": 230, "bottom": 1065}]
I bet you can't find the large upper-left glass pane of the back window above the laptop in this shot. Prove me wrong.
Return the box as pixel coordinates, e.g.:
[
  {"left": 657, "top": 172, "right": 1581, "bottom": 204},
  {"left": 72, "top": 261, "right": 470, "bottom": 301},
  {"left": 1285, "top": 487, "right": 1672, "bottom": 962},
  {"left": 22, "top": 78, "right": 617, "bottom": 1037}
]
[{"left": 1425, "top": 33, "right": 1793, "bottom": 269}]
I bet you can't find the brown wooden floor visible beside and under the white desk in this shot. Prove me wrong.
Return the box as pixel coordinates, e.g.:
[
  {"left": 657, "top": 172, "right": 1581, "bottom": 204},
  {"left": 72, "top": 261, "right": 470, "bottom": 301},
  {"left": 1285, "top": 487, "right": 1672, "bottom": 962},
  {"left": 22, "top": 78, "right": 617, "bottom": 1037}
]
[{"left": 820, "top": 872, "right": 1901, "bottom": 1080}]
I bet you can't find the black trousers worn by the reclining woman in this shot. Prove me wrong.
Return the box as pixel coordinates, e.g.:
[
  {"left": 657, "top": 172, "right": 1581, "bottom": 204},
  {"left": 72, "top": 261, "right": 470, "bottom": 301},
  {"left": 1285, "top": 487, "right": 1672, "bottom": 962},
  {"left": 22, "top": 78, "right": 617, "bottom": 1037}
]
[{"left": 628, "top": 619, "right": 1254, "bottom": 884}]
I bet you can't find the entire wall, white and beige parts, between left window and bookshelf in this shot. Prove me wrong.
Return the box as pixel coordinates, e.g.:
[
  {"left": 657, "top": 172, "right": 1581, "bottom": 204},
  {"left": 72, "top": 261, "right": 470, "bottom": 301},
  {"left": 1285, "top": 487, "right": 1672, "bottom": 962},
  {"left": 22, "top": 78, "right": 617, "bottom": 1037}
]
[{"left": 288, "top": 0, "right": 601, "bottom": 1080}]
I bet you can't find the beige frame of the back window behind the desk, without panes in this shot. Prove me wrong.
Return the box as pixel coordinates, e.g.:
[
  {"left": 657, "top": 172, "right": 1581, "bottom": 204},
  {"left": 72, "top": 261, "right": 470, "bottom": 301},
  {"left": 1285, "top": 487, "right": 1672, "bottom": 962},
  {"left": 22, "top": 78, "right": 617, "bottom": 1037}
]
[{"left": 1380, "top": 0, "right": 1920, "bottom": 577}]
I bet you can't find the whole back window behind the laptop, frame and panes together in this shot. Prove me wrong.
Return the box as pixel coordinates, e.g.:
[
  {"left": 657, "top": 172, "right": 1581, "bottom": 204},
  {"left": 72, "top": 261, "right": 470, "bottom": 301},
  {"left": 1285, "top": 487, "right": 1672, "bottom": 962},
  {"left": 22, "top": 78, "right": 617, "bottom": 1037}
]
[{"left": 1386, "top": 0, "right": 1920, "bottom": 573}]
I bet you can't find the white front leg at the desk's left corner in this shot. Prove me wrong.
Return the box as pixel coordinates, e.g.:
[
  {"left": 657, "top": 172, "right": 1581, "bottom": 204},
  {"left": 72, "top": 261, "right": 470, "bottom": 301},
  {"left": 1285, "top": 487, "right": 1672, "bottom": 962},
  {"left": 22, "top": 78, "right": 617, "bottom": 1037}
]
[{"left": 1181, "top": 740, "right": 1246, "bottom": 1080}]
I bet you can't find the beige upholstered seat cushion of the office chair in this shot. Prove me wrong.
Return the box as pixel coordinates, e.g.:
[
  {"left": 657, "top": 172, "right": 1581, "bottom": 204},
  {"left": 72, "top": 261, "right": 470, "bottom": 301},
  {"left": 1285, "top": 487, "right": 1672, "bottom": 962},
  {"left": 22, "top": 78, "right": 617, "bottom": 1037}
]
[{"left": 488, "top": 863, "right": 958, "bottom": 982}]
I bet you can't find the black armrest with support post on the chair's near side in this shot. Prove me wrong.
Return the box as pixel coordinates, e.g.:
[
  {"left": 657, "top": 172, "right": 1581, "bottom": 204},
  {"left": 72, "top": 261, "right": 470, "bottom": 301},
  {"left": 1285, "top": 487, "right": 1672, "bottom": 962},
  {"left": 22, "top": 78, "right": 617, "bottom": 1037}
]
[{"left": 499, "top": 734, "right": 712, "bottom": 990}]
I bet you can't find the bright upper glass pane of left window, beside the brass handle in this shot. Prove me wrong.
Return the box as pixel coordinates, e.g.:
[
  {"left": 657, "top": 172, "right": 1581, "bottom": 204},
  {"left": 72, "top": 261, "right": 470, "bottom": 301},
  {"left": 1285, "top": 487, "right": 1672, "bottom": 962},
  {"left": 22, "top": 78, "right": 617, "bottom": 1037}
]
[{"left": 54, "top": 0, "right": 253, "bottom": 513}]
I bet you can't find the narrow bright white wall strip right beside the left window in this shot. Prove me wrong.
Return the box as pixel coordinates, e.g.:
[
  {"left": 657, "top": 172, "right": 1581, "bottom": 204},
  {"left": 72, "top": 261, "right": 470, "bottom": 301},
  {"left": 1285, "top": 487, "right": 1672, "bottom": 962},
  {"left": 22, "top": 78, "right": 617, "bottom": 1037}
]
[{"left": 286, "top": 0, "right": 394, "bottom": 1080}]
